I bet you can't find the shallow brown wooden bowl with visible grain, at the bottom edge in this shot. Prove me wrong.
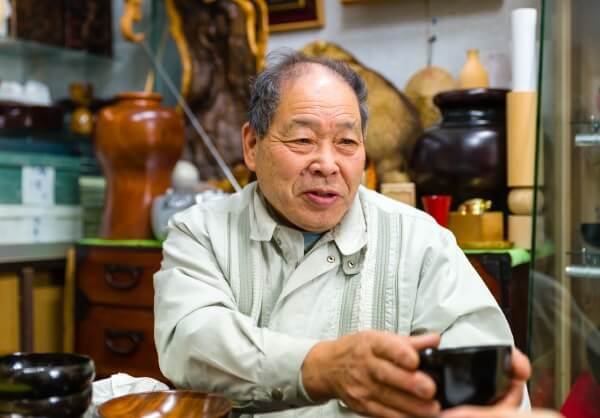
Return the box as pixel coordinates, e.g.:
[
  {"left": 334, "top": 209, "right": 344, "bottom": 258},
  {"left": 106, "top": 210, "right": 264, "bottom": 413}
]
[{"left": 98, "top": 390, "right": 231, "bottom": 418}]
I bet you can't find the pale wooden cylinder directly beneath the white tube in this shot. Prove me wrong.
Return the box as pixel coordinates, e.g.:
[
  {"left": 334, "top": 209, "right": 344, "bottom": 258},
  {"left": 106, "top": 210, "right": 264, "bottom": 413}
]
[{"left": 506, "top": 91, "right": 537, "bottom": 187}]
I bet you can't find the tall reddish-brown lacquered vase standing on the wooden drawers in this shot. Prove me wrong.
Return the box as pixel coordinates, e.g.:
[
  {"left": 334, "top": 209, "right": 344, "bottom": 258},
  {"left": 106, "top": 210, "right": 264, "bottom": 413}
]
[{"left": 95, "top": 92, "right": 184, "bottom": 239}]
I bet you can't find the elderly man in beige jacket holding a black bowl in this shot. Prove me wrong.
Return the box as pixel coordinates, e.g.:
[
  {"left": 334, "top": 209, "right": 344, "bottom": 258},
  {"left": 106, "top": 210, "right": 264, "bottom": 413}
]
[{"left": 154, "top": 53, "right": 529, "bottom": 417}]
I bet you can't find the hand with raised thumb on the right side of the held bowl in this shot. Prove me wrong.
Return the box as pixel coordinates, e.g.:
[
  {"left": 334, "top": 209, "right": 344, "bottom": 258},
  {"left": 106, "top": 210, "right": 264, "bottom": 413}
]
[{"left": 442, "top": 347, "right": 536, "bottom": 418}]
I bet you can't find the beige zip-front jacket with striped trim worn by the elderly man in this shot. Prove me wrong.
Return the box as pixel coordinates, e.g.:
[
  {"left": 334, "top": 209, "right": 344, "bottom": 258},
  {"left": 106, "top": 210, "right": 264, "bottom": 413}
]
[{"left": 154, "top": 183, "right": 512, "bottom": 417}]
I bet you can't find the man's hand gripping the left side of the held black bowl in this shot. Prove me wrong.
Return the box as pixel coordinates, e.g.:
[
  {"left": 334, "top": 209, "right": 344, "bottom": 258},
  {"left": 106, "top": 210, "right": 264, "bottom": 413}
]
[{"left": 302, "top": 331, "right": 440, "bottom": 418}]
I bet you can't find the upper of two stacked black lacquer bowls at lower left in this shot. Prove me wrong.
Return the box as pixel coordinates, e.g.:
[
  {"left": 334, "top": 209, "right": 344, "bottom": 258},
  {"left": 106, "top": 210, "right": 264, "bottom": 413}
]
[{"left": 0, "top": 353, "right": 94, "bottom": 401}]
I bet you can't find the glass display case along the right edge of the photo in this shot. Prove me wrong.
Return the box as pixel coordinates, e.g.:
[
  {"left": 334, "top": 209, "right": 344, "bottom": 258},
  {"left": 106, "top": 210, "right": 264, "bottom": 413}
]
[{"left": 529, "top": 0, "right": 600, "bottom": 412}]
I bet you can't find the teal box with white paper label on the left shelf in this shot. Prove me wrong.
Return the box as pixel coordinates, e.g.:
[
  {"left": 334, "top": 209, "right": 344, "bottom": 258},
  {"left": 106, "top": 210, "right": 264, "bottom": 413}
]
[{"left": 0, "top": 152, "right": 81, "bottom": 205}]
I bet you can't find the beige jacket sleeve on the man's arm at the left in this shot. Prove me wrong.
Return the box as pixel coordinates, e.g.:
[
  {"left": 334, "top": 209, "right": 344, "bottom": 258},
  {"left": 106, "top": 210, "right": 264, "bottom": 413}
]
[{"left": 154, "top": 208, "right": 317, "bottom": 410}]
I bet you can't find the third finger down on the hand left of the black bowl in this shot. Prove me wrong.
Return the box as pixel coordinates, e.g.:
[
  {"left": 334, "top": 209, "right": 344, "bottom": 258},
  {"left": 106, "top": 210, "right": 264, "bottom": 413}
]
[{"left": 369, "top": 357, "right": 436, "bottom": 400}]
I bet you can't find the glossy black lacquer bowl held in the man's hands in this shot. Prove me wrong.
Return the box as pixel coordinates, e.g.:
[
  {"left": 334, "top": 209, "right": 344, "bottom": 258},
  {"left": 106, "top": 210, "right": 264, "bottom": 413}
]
[{"left": 419, "top": 345, "right": 512, "bottom": 409}]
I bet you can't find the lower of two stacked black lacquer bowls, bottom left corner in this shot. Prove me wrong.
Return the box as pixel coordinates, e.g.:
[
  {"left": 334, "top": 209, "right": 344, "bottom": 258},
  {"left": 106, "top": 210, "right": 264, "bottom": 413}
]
[{"left": 0, "top": 386, "right": 92, "bottom": 418}]
